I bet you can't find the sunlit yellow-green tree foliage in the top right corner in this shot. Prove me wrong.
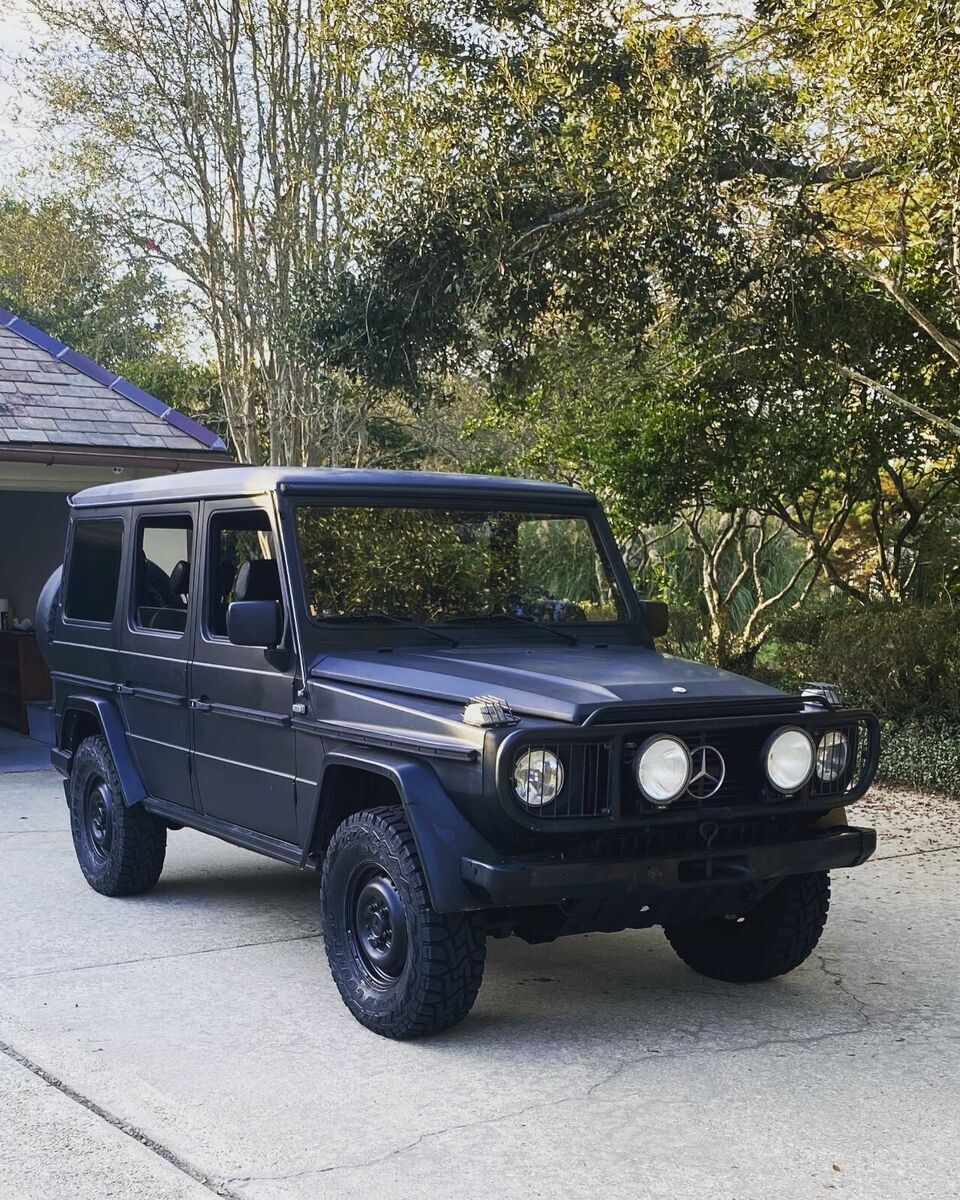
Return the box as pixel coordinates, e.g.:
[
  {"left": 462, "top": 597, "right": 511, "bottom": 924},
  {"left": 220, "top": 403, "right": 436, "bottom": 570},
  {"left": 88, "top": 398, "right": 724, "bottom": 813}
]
[{"left": 752, "top": 0, "right": 960, "bottom": 441}]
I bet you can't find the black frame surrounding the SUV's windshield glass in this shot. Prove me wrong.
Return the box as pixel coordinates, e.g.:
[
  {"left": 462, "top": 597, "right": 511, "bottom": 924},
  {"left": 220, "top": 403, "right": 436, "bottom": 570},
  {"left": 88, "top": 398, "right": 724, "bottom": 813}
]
[{"left": 282, "top": 491, "right": 649, "bottom": 649}]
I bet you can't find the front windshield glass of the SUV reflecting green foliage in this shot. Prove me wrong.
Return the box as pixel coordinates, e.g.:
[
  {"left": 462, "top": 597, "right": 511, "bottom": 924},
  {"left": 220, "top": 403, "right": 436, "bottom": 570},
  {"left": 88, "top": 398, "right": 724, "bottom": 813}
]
[{"left": 296, "top": 504, "right": 625, "bottom": 624}]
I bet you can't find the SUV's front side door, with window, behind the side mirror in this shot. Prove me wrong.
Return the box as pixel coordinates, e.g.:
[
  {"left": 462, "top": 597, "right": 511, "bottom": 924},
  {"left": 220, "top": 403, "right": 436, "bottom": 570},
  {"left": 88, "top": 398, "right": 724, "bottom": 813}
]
[{"left": 191, "top": 499, "right": 296, "bottom": 842}]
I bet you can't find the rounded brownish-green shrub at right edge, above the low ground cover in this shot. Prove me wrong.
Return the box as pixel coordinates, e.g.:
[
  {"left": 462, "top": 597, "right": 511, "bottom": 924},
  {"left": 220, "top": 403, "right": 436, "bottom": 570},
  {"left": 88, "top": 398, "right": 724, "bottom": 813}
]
[{"left": 776, "top": 604, "right": 960, "bottom": 724}]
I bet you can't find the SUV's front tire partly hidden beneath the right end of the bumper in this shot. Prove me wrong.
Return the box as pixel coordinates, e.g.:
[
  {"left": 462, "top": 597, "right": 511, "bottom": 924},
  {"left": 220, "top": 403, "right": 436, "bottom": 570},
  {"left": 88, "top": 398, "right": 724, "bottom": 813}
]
[{"left": 664, "top": 871, "right": 830, "bottom": 983}]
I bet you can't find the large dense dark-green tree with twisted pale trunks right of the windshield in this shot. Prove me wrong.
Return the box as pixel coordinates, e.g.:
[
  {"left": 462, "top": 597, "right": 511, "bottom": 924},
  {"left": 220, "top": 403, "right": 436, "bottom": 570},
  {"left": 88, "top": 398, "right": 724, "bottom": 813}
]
[{"left": 302, "top": 2, "right": 958, "bottom": 665}]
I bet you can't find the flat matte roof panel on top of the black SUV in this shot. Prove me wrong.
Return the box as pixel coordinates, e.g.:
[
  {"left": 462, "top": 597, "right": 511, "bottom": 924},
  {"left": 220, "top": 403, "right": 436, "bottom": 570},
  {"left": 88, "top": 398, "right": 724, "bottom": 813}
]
[{"left": 70, "top": 467, "right": 595, "bottom": 508}]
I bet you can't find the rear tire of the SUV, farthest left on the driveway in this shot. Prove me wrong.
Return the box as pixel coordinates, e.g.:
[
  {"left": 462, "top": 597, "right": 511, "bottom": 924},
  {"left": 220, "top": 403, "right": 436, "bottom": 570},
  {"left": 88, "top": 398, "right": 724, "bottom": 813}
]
[{"left": 70, "top": 737, "right": 167, "bottom": 896}]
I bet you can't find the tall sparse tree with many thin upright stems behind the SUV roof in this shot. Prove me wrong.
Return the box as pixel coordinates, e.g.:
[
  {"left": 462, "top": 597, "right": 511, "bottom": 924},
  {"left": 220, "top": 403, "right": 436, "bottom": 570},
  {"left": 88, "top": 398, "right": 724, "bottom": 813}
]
[{"left": 23, "top": 0, "right": 434, "bottom": 462}]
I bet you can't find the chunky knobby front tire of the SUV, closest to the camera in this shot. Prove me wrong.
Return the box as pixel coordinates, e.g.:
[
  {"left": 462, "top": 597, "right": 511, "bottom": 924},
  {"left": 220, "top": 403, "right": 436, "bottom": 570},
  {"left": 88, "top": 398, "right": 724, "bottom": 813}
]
[{"left": 322, "top": 808, "right": 486, "bottom": 1038}]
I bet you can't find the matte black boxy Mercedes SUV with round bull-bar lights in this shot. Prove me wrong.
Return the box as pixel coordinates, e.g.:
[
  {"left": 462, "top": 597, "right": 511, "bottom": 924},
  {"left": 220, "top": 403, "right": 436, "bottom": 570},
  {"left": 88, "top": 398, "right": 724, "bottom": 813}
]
[{"left": 37, "top": 467, "right": 878, "bottom": 1037}]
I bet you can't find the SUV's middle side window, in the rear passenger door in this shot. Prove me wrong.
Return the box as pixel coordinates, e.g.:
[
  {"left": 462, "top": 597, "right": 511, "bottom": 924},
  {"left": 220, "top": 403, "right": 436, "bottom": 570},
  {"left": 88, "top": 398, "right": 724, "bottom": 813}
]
[{"left": 133, "top": 516, "right": 193, "bottom": 634}]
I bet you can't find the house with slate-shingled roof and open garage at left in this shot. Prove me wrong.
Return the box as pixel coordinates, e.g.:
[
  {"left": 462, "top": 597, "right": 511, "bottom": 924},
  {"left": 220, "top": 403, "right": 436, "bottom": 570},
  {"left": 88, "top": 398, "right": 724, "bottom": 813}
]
[{"left": 0, "top": 308, "right": 227, "bottom": 638}]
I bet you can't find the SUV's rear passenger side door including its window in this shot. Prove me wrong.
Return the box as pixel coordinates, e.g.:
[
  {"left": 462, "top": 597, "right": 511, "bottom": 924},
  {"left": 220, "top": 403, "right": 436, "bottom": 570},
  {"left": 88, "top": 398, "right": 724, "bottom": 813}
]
[{"left": 118, "top": 504, "right": 198, "bottom": 808}]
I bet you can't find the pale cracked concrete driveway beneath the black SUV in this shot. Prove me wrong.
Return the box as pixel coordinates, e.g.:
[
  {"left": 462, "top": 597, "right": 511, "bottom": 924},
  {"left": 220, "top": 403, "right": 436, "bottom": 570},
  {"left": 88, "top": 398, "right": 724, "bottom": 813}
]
[{"left": 0, "top": 773, "right": 960, "bottom": 1200}]
